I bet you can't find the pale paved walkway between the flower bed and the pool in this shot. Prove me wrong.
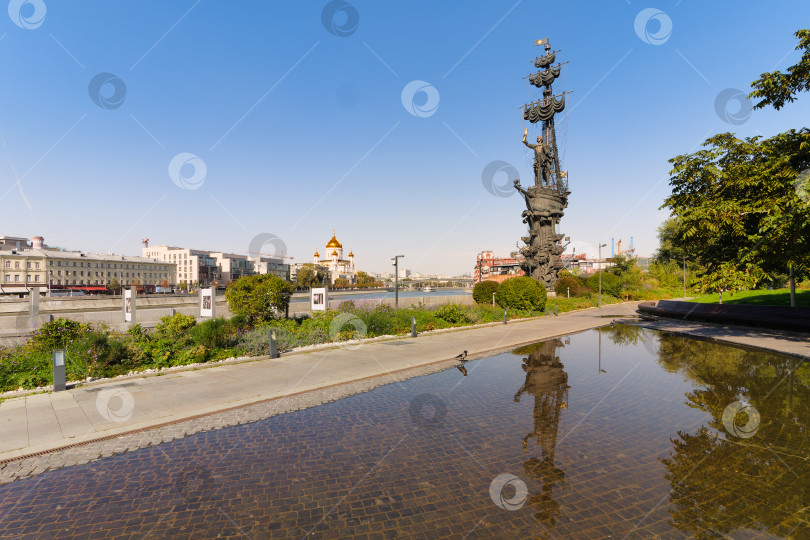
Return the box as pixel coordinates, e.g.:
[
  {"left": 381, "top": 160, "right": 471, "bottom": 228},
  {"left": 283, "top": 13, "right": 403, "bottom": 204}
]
[{"left": 0, "top": 303, "right": 637, "bottom": 461}]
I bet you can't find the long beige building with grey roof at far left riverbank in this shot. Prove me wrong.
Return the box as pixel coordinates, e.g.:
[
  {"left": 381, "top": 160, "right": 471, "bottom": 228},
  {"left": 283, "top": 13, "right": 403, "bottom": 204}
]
[{"left": 0, "top": 247, "right": 176, "bottom": 294}]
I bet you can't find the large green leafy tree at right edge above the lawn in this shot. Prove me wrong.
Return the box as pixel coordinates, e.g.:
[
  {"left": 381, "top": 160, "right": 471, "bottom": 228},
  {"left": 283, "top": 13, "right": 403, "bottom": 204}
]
[{"left": 664, "top": 128, "right": 810, "bottom": 290}]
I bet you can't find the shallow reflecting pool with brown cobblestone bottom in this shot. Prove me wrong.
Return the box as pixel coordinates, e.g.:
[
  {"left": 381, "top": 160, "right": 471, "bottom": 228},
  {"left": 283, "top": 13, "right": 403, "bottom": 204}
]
[{"left": 0, "top": 327, "right": 810, "bottom": 538}]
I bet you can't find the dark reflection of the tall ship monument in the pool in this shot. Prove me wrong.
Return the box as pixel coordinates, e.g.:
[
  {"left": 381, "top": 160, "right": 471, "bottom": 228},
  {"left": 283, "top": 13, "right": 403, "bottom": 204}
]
[{"left": 515, "top": 339, "right": 570, "bottom": 525}]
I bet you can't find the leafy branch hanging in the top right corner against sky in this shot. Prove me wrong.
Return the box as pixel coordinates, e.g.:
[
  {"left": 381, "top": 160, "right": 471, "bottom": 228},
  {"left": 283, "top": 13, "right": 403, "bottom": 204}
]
[{"left": 748, "top": 29, "right": 810, "bottom": 111}]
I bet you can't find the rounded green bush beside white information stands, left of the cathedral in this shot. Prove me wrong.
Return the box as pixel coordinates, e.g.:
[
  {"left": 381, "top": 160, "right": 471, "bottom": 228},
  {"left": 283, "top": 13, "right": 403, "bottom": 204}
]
[{"left": 225, "top": 274, "right": 293, "bottom": 323}]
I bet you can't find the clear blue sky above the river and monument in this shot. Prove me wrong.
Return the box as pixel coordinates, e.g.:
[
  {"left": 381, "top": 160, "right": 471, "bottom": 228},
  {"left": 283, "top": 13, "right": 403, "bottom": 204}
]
[{"left": 0, "top": 0, "right": 810, "bottom": 274}]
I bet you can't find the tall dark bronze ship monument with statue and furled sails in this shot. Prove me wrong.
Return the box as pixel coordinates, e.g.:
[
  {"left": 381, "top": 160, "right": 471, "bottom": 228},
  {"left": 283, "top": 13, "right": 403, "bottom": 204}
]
[{"left": 515, "top": 38, "right": 571, "bottom": 290}]
